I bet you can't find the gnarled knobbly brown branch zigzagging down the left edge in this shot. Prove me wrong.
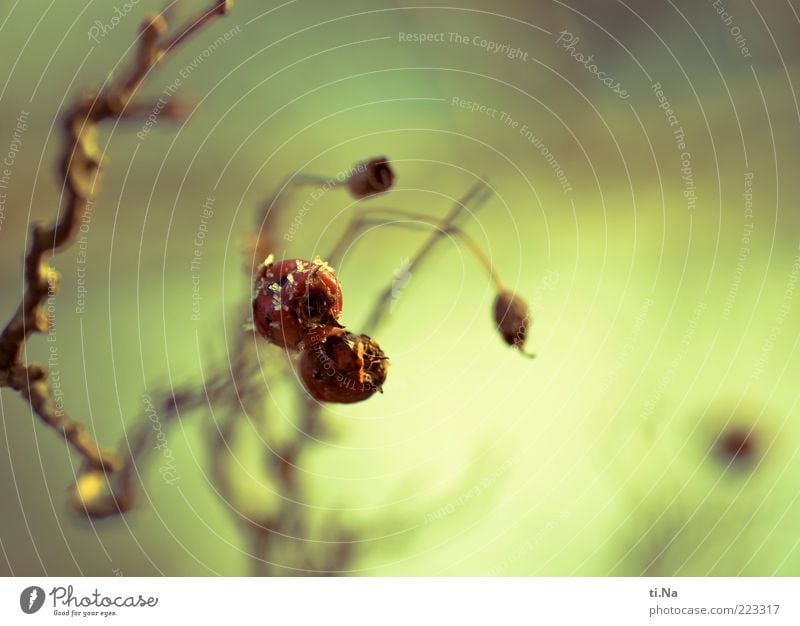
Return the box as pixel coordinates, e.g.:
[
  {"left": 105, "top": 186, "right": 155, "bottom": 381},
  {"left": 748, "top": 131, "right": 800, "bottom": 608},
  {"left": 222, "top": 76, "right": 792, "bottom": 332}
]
[{"left": 0, "top": 0, "right": 232, "bottom": 504}]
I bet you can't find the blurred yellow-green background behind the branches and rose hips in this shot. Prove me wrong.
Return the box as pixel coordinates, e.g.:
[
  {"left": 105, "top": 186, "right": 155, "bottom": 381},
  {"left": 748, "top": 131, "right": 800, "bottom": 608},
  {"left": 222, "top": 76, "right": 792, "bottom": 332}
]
[{"left": 0, "top": 0, "right": 800, "bottom": 576}]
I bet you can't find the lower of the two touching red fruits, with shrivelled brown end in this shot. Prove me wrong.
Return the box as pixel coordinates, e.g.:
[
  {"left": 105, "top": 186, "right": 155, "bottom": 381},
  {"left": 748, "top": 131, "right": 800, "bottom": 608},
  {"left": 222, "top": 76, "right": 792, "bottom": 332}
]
[{"left": 300, "top": 332, "right": 389, "bottom": 404}]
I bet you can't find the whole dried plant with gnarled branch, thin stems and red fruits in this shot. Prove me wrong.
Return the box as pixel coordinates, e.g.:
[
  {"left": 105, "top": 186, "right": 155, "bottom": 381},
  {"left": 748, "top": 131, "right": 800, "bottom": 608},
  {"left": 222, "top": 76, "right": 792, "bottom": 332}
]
[{"left": 0, "top": 0, "right": 529, "bottom": 574}]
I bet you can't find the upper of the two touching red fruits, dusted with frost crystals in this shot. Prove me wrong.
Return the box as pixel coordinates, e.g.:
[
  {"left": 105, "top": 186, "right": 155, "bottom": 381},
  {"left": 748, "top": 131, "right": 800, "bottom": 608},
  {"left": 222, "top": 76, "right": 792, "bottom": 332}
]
[{"left": 253, "top": 257, "right": 342, "bottom": 350}]
